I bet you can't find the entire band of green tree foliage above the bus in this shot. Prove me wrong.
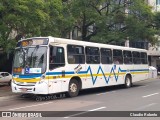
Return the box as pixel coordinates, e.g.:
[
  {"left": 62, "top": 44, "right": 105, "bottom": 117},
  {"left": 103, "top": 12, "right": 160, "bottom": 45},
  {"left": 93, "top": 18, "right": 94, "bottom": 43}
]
[{"left": 0, "top": 0, "right": 160, "bottom": 53}]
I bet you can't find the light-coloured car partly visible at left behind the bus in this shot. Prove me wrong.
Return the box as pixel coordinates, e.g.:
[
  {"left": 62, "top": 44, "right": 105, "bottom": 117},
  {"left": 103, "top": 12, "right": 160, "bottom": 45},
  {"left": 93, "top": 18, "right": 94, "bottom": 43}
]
[{"left": 0, "top": 72, "right": 12, "bottom": 85}]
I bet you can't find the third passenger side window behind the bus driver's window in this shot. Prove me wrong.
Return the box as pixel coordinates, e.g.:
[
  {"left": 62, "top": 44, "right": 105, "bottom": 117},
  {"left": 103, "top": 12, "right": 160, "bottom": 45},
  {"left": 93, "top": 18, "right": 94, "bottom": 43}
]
[{"left": 101, "top": 48, "right": 112, "bottom": 64}]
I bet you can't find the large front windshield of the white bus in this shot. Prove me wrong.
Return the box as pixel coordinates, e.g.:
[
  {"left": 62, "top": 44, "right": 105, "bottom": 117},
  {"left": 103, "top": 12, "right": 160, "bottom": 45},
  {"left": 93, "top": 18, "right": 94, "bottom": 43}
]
[{"left": 13, "top": 46, "right": 47, "bottom": 74}]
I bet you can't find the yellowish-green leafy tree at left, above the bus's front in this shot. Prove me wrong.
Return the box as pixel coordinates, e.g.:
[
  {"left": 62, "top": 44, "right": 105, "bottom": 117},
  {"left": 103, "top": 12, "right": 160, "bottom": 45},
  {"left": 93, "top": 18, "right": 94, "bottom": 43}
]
[{"left": 0, "top": 0, "right": 68, "bottom": 52}]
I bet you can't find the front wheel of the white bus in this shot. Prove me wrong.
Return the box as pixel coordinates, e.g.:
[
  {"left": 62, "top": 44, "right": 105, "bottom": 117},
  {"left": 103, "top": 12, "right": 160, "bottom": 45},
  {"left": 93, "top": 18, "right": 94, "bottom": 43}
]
[{"left": 68, "top": 79, "right": 79, "bottom": 97}]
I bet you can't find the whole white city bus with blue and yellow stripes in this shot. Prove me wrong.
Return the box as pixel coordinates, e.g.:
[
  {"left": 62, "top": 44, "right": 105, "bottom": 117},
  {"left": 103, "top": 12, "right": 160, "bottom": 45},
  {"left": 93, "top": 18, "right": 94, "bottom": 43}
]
[{"left": 12, "top": 37, "right": 149, "bottom": 97}]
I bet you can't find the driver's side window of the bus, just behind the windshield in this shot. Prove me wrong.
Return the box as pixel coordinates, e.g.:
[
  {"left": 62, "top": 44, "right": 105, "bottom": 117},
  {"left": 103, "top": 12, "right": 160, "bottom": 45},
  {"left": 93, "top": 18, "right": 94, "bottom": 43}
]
[{"left": 49, "top": 46, "right": 65, "bottom": 69}]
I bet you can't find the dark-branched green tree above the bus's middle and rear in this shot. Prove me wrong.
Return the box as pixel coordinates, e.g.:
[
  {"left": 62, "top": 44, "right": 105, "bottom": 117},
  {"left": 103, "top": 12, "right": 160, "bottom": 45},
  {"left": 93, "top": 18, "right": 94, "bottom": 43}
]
[{"left": 65, "top": 0, "right": 155, "bottom": 43}]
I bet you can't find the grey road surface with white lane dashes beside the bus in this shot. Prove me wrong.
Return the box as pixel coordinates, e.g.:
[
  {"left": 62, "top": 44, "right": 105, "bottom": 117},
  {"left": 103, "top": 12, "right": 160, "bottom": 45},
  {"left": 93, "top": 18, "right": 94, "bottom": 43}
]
[{"left": 0, "top": 79, "right": 160, "bottom": 120}]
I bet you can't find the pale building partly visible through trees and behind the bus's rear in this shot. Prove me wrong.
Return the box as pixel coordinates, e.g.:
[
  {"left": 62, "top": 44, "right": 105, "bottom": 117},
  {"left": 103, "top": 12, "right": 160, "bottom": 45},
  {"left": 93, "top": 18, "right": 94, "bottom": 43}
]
[{"left": 68, "top": 0, "right": 160, "bottom": 67}]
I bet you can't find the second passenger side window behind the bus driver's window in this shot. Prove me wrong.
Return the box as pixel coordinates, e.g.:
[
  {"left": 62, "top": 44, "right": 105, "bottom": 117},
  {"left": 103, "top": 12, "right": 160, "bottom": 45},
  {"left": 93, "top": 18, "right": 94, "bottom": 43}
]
[{"left": 85, "top": 47, "right": 100, "bottom": 64}]
